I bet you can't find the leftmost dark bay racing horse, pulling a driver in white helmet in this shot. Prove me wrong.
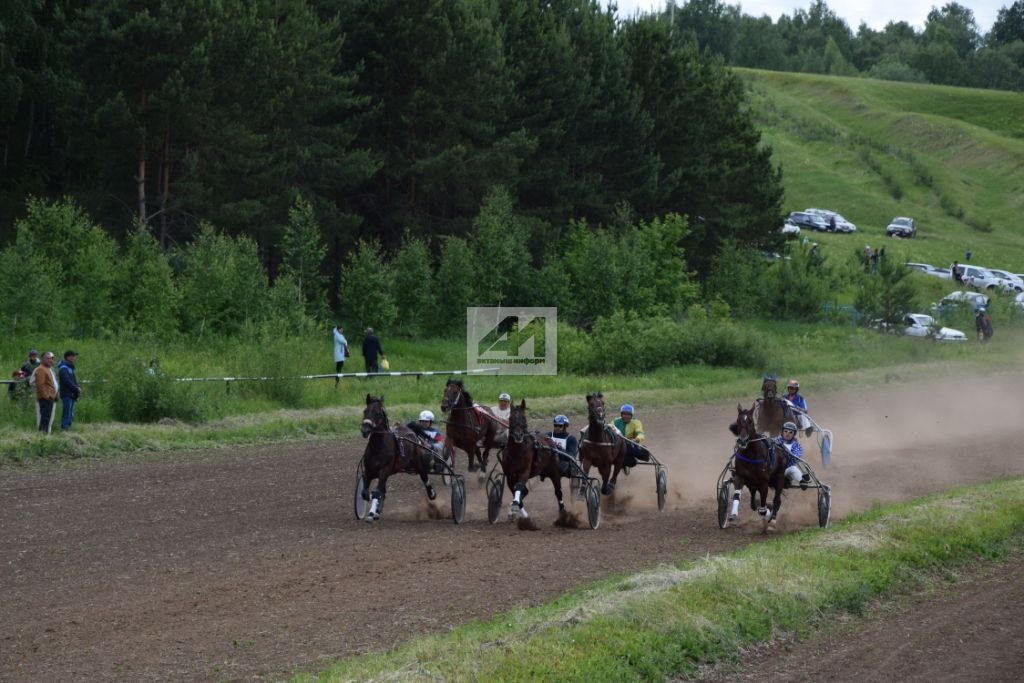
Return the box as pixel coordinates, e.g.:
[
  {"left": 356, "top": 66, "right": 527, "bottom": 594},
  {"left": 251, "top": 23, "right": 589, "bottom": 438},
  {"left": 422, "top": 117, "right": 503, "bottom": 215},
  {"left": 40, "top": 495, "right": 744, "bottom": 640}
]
[{"left": 359, "top": 393, "right": 437, "bottom": 521}]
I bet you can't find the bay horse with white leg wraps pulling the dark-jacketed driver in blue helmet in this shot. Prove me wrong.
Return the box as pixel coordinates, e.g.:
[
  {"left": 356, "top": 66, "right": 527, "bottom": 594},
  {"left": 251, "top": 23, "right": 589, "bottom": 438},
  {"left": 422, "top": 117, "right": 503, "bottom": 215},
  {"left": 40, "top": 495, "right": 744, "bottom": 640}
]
[{"left": 499, "top": 400, "right": 565, "bottom": 520}]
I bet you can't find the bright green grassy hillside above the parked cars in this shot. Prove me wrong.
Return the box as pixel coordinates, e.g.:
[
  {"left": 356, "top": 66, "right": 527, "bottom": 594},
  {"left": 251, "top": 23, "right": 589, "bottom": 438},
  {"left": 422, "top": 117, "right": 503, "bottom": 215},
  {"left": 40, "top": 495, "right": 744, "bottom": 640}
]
[{"left": 737, "top": 70, "right": 1024, "bottom": 272}]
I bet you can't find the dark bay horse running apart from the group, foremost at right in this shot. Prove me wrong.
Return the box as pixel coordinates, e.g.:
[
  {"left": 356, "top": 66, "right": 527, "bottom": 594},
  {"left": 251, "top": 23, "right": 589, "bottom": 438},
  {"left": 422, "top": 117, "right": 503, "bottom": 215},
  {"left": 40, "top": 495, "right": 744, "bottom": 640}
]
[{"left": 729, "top": 404, "right": 787, "bottom": 529}]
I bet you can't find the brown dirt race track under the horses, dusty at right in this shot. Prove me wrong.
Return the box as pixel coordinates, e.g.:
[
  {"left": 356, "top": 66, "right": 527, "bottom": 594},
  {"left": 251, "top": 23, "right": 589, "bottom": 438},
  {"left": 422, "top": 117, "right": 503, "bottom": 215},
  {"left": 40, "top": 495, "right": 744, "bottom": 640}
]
[{"left": 0, "top": 375, "right": 1024, "bottom": 681}]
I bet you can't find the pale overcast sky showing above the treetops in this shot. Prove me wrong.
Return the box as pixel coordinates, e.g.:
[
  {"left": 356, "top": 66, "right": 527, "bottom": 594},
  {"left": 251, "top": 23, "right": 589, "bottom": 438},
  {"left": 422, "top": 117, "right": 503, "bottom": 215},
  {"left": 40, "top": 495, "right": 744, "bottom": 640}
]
[{"left": 604, "top": 0, "right": 1014, "bottom": 35}]
